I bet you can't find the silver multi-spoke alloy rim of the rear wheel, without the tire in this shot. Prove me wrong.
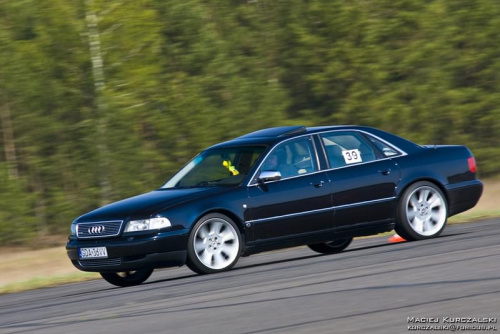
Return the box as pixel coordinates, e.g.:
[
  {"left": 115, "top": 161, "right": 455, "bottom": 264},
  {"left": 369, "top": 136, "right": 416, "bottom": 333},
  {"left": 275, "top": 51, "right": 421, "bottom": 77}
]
[{"left": 406, "top": 186, "right": 447, "bottom": 236}]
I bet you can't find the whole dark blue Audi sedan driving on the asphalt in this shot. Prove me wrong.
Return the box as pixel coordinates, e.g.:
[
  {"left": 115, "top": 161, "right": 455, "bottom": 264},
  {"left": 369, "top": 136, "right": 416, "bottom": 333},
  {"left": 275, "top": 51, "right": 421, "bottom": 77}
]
[{"left": 66, "top": 126, "right": 483, "bottom": 286}]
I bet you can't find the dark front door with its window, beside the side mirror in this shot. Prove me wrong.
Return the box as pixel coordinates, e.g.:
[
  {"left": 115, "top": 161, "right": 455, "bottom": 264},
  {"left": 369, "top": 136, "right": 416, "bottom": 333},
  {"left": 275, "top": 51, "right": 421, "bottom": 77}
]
[{"left": 247, "top": 136, "right": 333, "bottom": 243}]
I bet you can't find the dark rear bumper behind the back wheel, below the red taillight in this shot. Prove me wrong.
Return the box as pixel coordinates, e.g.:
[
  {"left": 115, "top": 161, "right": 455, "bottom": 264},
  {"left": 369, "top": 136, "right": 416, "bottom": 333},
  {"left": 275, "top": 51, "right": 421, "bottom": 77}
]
[{"left": 446, "top": 180, "right": 483, "bottom": 216}]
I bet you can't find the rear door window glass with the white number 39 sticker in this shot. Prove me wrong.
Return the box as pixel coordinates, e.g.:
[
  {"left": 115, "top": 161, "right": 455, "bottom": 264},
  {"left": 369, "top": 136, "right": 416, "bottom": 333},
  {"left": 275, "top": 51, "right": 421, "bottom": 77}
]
[{"left": 321, "top": 131, "right": 377, "bottom": 168}]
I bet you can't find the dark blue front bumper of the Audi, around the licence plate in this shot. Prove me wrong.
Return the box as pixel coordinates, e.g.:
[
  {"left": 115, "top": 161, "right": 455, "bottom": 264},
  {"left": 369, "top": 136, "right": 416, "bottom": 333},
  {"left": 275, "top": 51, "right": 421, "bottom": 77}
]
[{"left": 66, "top": 230, "right": 189, "bottom": 272}]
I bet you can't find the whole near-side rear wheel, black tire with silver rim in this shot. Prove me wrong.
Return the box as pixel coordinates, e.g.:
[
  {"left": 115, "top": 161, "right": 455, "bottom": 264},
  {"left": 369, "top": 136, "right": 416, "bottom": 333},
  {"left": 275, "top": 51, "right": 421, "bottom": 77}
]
[{"left": 395, "top": 181, "right": 448, "bottom": 241}]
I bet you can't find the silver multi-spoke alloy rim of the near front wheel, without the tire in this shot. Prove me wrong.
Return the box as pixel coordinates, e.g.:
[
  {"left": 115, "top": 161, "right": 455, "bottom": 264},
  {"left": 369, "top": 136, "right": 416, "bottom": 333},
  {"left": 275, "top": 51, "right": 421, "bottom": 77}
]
[{"left": 193, "top": 218, "right": 240, "bottom": 270}]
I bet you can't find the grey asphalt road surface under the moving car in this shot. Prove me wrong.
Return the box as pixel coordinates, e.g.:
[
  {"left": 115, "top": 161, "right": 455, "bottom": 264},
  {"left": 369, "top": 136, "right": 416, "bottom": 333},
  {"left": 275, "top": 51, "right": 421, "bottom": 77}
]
[{"left": 0, "top": 220, "right": 500, "bottom": 334}]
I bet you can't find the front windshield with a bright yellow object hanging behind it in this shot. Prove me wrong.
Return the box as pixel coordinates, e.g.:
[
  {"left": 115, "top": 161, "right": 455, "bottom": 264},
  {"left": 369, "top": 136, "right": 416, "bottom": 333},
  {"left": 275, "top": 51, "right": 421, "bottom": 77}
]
[{"left": 162, "top": 146, "right": 265, "bottom": 188}]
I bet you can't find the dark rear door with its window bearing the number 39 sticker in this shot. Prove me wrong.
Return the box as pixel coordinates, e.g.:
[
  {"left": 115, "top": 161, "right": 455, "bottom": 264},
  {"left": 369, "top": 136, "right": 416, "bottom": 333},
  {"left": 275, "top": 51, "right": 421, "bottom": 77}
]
[{"left": 320, "top": 131, "right": 401, "bottom": 232}]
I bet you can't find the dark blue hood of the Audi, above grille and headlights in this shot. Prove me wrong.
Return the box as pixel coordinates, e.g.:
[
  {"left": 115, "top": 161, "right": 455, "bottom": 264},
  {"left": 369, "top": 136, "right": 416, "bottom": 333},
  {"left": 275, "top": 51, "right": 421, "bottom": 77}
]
[{"left": 77, "top": 187, "right": 228, "bottom": 223}]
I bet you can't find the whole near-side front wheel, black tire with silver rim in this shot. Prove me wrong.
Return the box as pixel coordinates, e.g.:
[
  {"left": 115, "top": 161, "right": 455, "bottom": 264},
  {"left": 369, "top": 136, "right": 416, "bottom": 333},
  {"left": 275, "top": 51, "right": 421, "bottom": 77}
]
[{"left": 186, "top": 213, "right": 243, "bottom": 274}]
